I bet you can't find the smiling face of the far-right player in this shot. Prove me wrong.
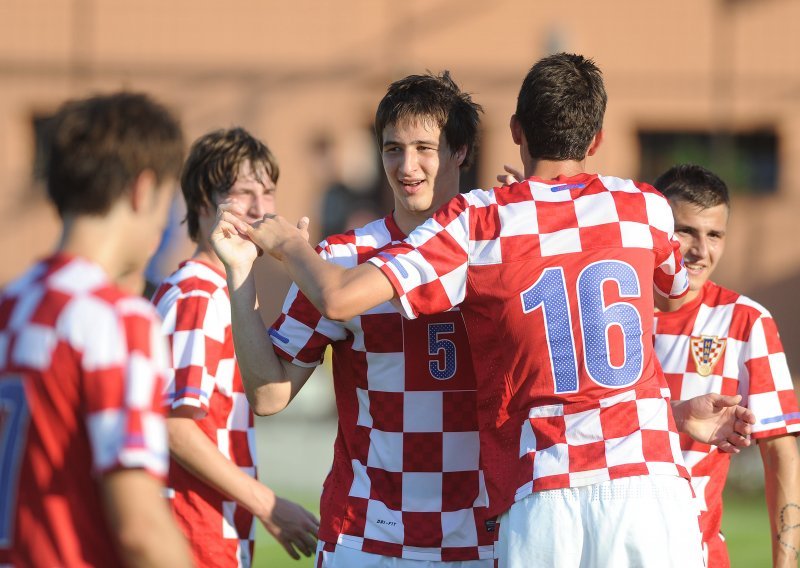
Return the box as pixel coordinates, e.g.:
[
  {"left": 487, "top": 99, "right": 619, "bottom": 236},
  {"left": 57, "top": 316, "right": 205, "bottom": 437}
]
[{"left": 669, "top": 199, "right": 729, "bottom": 299}]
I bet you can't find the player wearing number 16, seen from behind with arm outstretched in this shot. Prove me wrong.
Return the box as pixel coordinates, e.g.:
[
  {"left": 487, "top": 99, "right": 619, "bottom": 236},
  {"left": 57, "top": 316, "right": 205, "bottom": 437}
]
[{"left": 211, "top": 54, "right": 756, "bottom": 566}]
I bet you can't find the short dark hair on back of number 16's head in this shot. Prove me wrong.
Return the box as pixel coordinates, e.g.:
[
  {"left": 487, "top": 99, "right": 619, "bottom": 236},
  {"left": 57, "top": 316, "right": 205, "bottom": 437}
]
[{"left": 516, "top": 53, "right": 608, "bottom": 161}]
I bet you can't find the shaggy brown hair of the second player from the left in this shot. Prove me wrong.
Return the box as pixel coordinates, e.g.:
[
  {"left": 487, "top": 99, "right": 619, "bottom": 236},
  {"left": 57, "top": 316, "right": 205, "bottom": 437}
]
[{"left": 181, "top": 127, "right": 280, "bottom": 241}]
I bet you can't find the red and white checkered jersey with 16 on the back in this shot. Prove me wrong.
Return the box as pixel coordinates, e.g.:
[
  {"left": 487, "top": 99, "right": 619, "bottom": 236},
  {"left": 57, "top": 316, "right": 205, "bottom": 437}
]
[{"left": 370, "top": 174, "right": 687, "bottom": 513}]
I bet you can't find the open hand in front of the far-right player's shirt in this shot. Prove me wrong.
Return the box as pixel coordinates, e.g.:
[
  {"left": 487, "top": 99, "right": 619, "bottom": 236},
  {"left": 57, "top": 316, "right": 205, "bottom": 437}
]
[{"left": 672, "top": 393, "right": 756, "bottom": 453}]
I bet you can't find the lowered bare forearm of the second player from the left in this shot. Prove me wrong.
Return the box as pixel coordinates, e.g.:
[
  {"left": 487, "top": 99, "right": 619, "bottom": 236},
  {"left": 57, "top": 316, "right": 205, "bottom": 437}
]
[{"left": 167, "top": 417, "right": 275, "bottom": 516}]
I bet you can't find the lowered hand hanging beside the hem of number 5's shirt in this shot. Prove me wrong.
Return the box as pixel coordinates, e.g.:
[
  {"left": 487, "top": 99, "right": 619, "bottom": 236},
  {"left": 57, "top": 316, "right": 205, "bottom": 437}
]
[{"left": 259, "top": 494, "right": 319, "bottom": 560}]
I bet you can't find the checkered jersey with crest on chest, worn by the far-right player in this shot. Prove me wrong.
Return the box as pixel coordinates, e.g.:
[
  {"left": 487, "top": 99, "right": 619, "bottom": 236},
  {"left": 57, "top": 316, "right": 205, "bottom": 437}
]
[{"left": 655, "top": 281, "right": 800, "bottom": 565}]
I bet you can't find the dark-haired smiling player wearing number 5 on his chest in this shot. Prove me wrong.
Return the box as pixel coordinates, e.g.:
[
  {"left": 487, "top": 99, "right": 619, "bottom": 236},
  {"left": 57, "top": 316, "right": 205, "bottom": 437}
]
[{"left": 213, "top": 72, "right": 494, "bottom": 568}]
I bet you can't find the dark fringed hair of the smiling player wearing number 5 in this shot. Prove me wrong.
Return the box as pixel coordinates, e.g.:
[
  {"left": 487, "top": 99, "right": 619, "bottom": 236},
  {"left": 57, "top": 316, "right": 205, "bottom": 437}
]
[{"left": 375, "top": 71, "right": 483, "bottom": 168}]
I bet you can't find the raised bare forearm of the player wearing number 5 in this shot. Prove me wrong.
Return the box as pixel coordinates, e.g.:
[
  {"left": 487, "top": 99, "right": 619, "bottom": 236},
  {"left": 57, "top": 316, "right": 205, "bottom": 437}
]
[{"left": 227, "top": 266, "right": 296, "bottom": 416}]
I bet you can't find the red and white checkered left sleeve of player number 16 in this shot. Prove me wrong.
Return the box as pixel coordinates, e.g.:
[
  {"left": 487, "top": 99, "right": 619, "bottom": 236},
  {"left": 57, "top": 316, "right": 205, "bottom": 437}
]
[{"left": 369, "top": 195, "right": 470, "bottom": 319}]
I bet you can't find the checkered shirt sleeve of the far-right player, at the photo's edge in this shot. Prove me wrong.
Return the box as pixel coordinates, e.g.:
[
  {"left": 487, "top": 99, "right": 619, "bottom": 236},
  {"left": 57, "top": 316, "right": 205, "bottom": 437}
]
[{"left": 736, "top": 304, "right": 800, "bottom": 438}]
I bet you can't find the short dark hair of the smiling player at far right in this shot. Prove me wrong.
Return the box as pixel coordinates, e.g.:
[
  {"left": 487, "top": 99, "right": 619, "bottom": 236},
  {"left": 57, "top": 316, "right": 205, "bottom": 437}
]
[{"left": 653, "top": 164, "right": 731, "bottom": 209}]
